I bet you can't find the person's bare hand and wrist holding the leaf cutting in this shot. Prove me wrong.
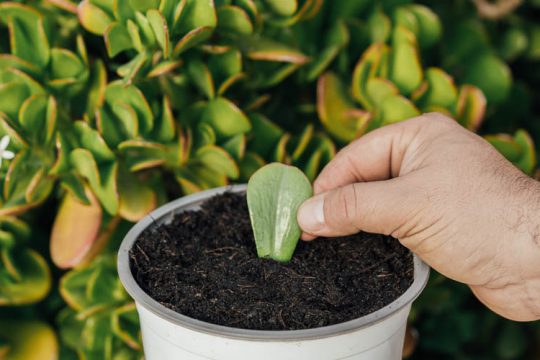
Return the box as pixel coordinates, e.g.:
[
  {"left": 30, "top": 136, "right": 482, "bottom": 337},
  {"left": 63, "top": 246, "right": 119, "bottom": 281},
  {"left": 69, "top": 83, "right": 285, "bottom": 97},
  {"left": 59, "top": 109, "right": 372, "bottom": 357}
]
[{"left": 298, "top": 113, "right": 540, "bottom": 321}]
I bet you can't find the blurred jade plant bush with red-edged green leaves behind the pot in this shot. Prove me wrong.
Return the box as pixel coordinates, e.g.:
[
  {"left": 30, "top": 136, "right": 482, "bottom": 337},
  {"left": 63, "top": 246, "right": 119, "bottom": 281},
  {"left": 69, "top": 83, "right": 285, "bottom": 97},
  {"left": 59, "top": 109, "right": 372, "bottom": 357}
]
[{"left": 0, "top": 0, "right": 538, "bottom": 358}]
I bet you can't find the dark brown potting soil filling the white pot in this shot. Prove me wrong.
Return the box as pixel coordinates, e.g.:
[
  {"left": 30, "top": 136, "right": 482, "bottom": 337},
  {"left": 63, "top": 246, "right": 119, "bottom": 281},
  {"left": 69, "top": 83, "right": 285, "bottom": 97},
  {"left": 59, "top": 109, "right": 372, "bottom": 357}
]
[{"left": 130, "top": 193, "right": 414, "bottom": 330}]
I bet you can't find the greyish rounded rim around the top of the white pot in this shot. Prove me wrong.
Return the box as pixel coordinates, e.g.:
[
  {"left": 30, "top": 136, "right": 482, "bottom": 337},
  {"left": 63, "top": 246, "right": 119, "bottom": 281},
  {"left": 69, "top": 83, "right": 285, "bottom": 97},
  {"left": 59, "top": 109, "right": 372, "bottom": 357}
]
[{"left": 117, "top": 184, "right": 429, "bottom": 341}]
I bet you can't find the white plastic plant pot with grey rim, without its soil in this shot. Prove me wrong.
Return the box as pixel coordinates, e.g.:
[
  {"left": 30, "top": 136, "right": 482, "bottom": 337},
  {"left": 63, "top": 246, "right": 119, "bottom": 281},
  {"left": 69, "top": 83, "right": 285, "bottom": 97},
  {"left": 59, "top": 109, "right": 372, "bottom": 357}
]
[{"left": 118, "top": 185, "right": 429, "bottom": 360}]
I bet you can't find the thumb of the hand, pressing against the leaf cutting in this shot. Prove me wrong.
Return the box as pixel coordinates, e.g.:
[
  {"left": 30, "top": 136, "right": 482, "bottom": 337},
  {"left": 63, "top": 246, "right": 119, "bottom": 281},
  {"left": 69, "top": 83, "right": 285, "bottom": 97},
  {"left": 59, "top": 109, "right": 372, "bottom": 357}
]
[{"left": 297, "top": 178, "right": 418, "bottom": 240}]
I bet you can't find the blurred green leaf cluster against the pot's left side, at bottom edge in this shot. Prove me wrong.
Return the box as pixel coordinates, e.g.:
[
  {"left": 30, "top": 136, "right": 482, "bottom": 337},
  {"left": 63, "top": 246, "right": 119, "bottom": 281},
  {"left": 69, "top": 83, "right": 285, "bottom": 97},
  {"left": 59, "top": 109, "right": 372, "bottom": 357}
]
[{"left": 57, "top": 256, "right": 141, "bottom": 359}]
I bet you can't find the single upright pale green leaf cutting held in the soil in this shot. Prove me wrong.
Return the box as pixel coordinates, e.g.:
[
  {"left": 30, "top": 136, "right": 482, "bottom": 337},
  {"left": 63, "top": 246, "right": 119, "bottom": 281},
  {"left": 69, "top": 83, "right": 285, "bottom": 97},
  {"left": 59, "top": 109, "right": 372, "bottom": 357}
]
[{"left": 247, "top": 163, "right": 313, "bottom": 262}]
